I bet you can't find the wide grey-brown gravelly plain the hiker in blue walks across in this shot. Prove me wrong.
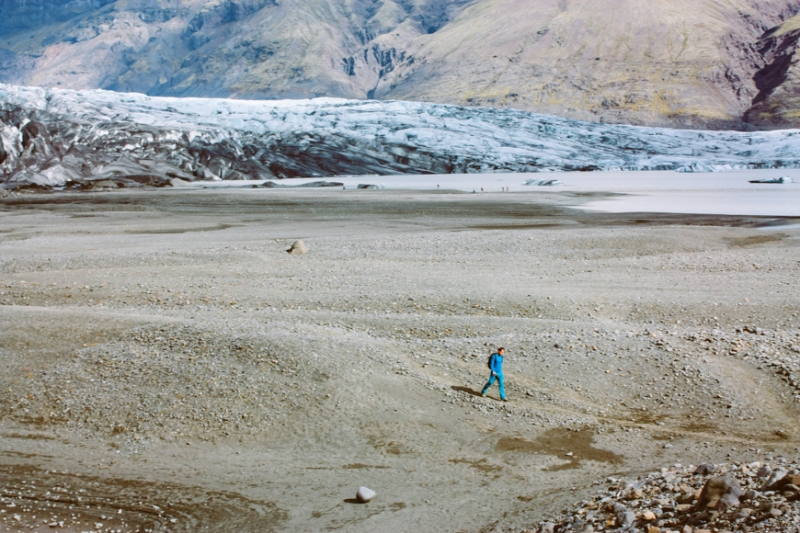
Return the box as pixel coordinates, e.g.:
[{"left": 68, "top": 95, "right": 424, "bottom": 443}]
[{"left": 0, "top": 173, "right": 800, "bottom": 532}]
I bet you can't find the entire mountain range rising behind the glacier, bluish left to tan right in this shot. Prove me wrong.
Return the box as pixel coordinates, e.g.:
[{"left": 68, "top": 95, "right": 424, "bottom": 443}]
[{"left": 0, "top": 0, "right": 800, "bottom": 129}]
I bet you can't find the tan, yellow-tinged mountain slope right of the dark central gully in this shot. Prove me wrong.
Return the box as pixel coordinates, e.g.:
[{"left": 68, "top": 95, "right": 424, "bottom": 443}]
[{"left": 379, "top": 0, "right": 800, "bottom": 127}]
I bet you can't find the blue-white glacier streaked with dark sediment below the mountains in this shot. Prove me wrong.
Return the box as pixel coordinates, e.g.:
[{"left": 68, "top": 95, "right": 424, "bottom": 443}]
[{"left": 0, "top": 84, "right": 800, "bottom": 189}]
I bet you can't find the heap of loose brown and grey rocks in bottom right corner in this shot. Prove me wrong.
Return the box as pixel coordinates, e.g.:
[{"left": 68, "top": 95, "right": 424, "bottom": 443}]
[{"left": 524, "top": 459, "right": 800, "bottom": 533}]
